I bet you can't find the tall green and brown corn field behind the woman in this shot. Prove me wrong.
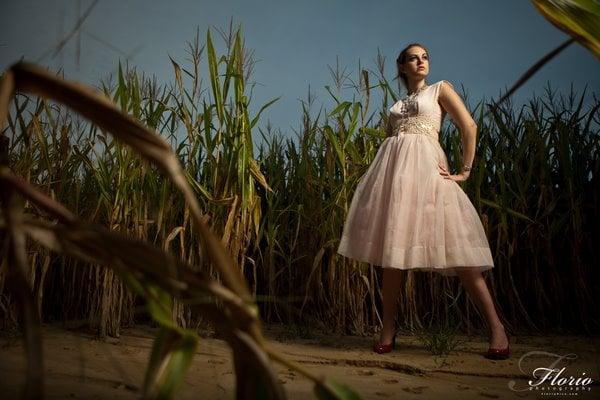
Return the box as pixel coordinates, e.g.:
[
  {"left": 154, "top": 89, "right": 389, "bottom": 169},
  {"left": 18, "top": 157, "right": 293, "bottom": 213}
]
[{"left": 0, "top": 25, "right": 600, "bottom": 346}]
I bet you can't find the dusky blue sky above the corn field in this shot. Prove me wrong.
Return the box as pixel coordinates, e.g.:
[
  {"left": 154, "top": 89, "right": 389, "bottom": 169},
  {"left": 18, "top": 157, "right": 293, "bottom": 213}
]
[{"left": 0, "top": 0, "right": 600, "bottom": 147}]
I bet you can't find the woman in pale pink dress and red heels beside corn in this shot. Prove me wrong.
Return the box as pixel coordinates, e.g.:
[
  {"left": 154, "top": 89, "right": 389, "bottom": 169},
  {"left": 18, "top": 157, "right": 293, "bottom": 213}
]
[{"left": 337, "top": 43, "right": 510, "bottom": 359}]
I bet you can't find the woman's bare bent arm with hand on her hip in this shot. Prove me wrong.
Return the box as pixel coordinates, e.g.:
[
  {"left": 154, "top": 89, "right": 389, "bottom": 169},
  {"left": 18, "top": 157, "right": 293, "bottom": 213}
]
[{"left": 438, "top": 81, "right": 477, "bottom": 176}]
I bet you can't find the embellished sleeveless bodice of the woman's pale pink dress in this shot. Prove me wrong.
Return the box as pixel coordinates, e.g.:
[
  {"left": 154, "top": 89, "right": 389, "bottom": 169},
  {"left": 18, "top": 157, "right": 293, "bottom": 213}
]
[{"left": 389, "top": 80, "right": 444, "bottom": 140}]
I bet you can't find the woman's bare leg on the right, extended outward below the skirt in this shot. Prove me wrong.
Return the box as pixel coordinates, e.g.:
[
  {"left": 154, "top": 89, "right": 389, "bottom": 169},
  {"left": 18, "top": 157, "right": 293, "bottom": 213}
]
[{"left": 456, "top": 268, "right": 508, "bottom": 349}]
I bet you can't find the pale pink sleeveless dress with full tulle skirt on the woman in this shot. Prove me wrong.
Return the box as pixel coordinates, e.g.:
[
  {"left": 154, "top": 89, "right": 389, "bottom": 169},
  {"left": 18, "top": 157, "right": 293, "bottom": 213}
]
[{"left": 337, "top": 80, "right": 494, "bottom": 276}]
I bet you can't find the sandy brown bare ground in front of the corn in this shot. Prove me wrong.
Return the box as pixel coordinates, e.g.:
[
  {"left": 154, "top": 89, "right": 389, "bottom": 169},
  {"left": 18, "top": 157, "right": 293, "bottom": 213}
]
[{"left": 0, "top": 325, "right": 600, "bottom": 400}]
